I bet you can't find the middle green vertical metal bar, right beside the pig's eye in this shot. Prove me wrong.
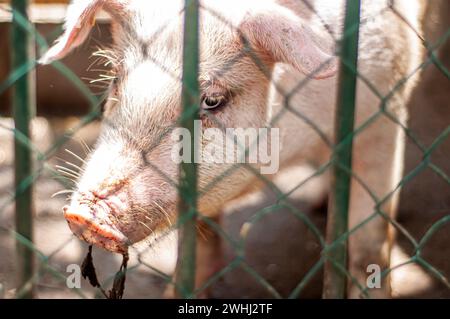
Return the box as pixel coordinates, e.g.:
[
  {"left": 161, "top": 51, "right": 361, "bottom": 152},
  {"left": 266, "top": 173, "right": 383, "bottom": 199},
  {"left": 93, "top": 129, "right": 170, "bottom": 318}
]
[{"left": 176, "top": 0, "right": 200, "bottom": 298}]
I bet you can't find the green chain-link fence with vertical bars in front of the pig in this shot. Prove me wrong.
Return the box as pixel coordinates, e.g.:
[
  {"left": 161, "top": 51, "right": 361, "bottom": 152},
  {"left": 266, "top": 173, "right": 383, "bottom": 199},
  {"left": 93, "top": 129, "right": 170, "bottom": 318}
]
[{"left": 0, "top": 0, "right": 450, "bottom": 298}]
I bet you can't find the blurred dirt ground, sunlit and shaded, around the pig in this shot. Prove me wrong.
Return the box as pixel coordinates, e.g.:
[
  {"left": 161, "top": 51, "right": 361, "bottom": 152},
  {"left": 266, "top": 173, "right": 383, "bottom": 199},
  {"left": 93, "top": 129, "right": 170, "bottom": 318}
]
[{"left": 0, "top": 1, "right": 450, "bottom": 298}]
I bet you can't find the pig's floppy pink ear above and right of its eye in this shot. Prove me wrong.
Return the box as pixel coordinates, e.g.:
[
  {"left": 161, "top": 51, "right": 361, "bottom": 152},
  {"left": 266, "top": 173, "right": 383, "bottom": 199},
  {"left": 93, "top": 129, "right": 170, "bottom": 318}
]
[{"left": 240, "top": 5, "right": 337, "bottom": 79}]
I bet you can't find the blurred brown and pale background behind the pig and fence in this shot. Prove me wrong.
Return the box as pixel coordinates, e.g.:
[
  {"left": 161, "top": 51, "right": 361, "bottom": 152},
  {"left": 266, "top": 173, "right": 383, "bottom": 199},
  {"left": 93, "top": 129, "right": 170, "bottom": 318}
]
[{"left": 0, "top": 0, "right": 450, "bottom": 298}]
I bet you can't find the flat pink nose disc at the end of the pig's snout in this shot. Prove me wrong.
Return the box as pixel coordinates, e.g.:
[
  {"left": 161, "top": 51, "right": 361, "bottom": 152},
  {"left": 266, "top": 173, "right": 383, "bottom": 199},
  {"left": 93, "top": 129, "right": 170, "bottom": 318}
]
[{"left": 63, "top": 205, "right": 128, "bottom": 254}]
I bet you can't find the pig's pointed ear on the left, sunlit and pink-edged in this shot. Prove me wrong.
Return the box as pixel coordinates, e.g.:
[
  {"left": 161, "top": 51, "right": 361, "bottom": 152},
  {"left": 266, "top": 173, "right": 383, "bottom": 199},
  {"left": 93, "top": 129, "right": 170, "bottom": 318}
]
[{"left": 39, "top": 0, "right": 105, "bottom": 64}]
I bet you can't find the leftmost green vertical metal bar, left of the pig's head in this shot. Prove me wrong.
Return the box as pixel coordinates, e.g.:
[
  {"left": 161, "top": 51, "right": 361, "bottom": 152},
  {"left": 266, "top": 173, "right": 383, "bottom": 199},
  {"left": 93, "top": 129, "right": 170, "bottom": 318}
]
[{"left": 11, "top": 0, "right": 35, "bottom": 298}]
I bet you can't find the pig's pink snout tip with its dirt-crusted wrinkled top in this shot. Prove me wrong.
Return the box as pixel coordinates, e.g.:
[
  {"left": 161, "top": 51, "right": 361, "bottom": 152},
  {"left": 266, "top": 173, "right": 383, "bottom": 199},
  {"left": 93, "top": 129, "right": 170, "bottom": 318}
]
[{"left": 63, "top": 190, "right": 131, "bottom": 254}]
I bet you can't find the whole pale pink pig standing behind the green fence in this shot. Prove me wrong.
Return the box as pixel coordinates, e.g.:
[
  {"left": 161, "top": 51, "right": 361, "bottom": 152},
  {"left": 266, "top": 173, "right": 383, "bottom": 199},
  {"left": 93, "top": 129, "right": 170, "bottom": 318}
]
[{"left": 41, "top": 0, "right": 423, "bottom": 298}]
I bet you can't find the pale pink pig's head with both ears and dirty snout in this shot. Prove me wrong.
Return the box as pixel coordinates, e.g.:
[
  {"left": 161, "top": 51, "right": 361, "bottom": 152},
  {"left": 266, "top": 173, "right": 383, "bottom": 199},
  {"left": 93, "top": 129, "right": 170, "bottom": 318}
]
[{"left": 41, "top": 0, "right": 335, "bottom": 252}]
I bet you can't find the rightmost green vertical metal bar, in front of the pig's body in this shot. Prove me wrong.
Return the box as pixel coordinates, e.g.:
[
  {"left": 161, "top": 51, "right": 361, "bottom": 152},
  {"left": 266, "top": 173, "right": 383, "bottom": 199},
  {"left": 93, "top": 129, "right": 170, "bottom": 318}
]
[{"left": 323, "top": 0, "right": 361, "bottom": 299}]
